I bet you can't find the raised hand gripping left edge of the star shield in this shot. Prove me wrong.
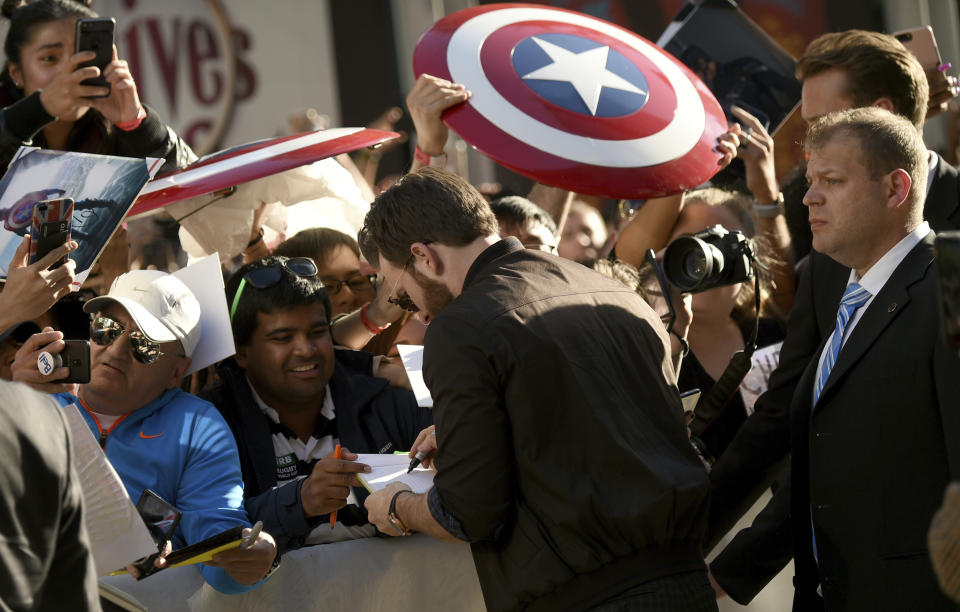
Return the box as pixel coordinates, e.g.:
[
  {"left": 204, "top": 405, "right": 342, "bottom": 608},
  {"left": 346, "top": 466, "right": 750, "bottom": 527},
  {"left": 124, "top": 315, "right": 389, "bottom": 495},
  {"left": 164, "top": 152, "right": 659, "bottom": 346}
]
[{"left": 407, "top": 74, "right": 470, "bottom": 156}]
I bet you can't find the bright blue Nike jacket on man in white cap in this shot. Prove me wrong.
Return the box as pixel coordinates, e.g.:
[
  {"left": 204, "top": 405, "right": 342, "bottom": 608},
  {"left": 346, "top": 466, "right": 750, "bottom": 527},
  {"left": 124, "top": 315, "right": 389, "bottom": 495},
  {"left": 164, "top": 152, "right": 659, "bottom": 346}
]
[{"left": 54, "top": 389, "right": 260, "bottom": 594}]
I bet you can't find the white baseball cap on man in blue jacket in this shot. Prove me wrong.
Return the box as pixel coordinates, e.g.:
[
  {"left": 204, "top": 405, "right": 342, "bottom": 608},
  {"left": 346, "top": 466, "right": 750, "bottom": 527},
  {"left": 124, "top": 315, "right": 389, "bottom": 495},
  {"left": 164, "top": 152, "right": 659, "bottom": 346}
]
[{"left": 83, "top": 270, "right": 202, "bottom": 357}]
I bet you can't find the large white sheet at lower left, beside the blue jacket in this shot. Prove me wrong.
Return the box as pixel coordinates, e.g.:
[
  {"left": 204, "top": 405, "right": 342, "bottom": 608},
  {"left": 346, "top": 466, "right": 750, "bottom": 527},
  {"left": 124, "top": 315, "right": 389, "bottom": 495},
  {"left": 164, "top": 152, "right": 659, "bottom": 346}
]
[{"left": 63, "top": 404, "right": 157, "bottom": 576}]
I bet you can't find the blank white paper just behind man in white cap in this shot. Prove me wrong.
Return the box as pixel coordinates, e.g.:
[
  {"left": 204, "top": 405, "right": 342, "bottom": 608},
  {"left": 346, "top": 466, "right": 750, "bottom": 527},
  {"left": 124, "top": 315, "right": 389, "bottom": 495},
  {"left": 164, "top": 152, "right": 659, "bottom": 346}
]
[{"left": 173, "top": 253, "right": 236, "bottom": 374}]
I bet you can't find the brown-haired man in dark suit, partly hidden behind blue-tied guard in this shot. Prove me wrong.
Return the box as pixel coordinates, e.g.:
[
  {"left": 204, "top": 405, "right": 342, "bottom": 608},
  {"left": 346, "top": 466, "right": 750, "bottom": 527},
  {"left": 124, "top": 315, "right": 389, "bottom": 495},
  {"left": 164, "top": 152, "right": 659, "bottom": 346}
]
[{"left": 707, "top": 30, "right": 960, "bottom": 548}]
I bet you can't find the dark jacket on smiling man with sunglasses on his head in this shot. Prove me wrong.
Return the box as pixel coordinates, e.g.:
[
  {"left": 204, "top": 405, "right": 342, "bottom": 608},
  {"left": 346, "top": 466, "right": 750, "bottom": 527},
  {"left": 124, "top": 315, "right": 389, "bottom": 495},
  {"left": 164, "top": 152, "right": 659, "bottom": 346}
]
[{"left": 200, "top": 349, "right": 433, "bottom": 552}]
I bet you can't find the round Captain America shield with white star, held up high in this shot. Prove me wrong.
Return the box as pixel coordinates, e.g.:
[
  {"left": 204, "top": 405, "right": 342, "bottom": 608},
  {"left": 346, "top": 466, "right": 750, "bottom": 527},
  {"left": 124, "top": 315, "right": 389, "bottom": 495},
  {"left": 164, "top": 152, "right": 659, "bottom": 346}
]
[{"left": 413, "top": 4, "right": 727, "bottom": 199}]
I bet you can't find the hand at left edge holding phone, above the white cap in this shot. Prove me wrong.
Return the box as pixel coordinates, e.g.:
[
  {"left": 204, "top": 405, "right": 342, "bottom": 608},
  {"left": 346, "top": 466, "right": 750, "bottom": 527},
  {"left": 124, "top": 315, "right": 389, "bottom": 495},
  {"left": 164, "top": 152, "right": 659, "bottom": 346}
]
[{"left": 0, "top": 236, "right": 77, "bottom": 329}]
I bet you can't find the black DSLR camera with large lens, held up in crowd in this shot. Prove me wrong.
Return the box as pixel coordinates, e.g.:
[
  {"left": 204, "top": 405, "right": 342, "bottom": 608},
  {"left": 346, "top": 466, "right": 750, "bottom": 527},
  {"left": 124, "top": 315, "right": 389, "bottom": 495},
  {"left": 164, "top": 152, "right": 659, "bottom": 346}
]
[{"left": 663, "top": 225, "right": 754, "bottom": 293}]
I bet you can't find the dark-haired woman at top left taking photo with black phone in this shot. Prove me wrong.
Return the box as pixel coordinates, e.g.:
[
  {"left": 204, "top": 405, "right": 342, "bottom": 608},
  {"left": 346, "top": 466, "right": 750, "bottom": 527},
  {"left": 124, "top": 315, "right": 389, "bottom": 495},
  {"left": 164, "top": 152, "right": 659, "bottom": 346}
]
[{"left": 0, "top": 0, "right": 196, "bottom": 172}]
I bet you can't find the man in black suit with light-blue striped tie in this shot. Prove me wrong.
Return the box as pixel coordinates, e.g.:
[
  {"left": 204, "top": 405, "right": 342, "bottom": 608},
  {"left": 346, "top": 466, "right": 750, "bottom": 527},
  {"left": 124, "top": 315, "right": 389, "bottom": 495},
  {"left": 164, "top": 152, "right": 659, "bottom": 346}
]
[{"left": 711, "top": 107, "right": 960, "bottom": 610}]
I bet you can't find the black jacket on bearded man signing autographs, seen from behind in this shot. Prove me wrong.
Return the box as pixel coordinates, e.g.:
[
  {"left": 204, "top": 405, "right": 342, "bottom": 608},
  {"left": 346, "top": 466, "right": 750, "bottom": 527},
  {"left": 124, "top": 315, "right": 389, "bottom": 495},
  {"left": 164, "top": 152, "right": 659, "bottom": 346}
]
[{"left": 424, "top": 238, "right": 708, "bottom": 610}]
